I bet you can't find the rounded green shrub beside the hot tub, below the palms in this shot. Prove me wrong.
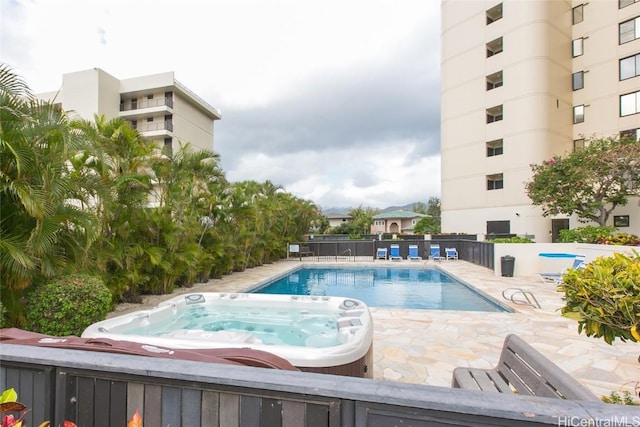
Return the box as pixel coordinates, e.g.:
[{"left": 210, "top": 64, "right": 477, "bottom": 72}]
[{"left": 25, "top": 275, "right": 111, "bottom": 336}]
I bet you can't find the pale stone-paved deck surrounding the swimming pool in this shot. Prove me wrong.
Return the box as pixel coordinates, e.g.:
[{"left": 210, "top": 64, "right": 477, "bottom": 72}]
[{"left": 110, "top": 260, "right": 640, "bottom": 396}]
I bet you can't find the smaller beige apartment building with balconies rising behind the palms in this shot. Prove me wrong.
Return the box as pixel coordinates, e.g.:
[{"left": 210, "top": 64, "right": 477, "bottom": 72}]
[{"left": 36, "top": 68, "right": 221, "bottom": 156}]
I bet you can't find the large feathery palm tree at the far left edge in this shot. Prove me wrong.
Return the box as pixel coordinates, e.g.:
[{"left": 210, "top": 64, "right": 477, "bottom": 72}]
[{"left": 0, "top": 65, "right": 97, "bottom": 324}]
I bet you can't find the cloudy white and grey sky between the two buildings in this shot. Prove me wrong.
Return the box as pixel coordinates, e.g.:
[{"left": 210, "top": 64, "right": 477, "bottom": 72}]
[{"left": 0, "top": 0, "right": 440, "bottom": 209}]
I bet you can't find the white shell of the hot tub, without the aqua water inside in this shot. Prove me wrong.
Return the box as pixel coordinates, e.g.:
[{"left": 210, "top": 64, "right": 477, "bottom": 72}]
[{"left": 82, "top": 292, "right": 373, "bottom": 377}]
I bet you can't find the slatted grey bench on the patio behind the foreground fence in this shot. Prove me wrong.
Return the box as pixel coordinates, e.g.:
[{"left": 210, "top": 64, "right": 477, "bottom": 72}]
[{"left": 452, "top": 334, "right": 600, "bottom": 401}]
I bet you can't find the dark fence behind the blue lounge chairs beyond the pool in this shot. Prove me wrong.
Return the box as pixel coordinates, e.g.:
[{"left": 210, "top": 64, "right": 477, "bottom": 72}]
[{"left": 292, "top": 236, "right": 495, "bottom": 270}]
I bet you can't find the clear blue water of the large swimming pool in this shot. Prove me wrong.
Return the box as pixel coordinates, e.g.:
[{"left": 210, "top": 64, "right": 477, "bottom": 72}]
[{"left": 253, "top": 267, "right": 507, "bottom": 311}]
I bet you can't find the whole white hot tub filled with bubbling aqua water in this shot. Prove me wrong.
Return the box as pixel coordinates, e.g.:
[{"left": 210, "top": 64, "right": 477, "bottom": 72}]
[{"left": 82, "top": 292, "right": 373, "bottom": 378}]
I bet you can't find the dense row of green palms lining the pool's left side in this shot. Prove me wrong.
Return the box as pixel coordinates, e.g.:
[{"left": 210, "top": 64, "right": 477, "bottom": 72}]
[{"left": 0, "top": 66, "right": 326, "bottom": 320}]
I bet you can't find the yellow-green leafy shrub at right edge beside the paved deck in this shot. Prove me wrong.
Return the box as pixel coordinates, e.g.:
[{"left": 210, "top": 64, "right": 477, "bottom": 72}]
[{"left": 558, "top": 251, "right": 640, "bottom": 344}]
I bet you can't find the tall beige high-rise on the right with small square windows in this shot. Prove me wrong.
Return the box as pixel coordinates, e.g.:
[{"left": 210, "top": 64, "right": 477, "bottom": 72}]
[{"left": 441, "top": 0, "right": 640, "bottom": 242}]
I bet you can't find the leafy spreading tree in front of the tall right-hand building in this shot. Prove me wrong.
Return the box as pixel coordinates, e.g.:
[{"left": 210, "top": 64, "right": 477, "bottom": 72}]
[{"left": 525, "top": 137, "right": 640, "bottom": 227}]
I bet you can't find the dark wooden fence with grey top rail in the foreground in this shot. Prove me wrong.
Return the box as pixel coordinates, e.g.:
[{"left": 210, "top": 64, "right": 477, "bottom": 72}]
[{"left": 0, "top": 344, "right": 638, "bottom": 427}]
